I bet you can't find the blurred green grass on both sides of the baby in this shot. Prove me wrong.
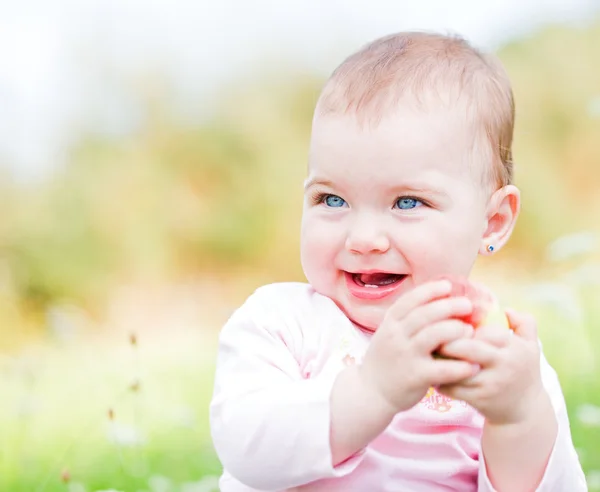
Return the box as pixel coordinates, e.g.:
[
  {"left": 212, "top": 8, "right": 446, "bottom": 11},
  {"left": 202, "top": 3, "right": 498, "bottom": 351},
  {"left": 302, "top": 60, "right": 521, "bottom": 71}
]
[{"left": 0, "top": 270, "right": 600, "bottom": 492}]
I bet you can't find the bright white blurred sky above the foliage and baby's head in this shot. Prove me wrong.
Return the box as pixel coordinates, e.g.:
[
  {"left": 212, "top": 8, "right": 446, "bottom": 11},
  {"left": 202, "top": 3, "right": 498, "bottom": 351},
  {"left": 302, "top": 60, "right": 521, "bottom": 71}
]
[{"left": 0, "top": 0, "right": 600, "bottom": 179}]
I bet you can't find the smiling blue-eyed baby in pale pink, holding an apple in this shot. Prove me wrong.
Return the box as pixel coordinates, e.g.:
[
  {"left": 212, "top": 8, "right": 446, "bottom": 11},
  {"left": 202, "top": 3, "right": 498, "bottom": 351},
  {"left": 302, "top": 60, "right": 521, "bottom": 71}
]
[{"left": 211, "top": 33, "right": 587, "bottom": 492}]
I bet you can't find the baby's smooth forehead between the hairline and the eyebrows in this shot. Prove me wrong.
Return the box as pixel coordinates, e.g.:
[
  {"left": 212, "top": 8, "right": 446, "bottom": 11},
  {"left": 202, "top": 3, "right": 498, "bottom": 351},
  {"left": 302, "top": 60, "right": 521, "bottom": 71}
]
[{"left": 309, "top": 108, "right": 489, "bottom": 193}]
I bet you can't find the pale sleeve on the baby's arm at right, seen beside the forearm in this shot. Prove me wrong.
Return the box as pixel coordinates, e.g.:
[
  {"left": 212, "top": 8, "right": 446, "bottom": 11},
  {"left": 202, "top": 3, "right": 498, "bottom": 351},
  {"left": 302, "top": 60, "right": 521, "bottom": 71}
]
[{"left": 477, "top": 353, "right": 588, "bottom": 492}]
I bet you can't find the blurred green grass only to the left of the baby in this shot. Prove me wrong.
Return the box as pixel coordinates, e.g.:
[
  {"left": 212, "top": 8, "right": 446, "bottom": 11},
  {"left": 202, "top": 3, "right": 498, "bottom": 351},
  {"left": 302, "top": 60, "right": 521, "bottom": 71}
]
[{"left": 0, "top": 335, "right": 220, "bottom": 492}]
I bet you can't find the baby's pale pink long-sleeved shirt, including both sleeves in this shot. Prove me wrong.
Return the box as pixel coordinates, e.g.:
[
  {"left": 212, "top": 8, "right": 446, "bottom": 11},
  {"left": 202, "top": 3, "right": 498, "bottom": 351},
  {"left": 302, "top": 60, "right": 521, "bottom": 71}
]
[{"left": 210, "top": 283, "right": 587, "bottom": 492}]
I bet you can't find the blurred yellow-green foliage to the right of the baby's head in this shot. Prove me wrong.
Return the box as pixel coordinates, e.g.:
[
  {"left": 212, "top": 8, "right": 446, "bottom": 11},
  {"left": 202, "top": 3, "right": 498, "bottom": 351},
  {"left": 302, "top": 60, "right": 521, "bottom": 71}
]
[{"left": 499, "top": 22, "right": 600, "bottom": 265}]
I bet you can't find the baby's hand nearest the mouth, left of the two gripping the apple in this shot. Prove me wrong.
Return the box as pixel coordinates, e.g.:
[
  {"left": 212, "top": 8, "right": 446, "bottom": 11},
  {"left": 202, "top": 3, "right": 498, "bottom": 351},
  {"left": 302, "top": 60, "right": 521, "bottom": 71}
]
[{"left": 359, "top": 280, "right": 480, "bottom": 413}]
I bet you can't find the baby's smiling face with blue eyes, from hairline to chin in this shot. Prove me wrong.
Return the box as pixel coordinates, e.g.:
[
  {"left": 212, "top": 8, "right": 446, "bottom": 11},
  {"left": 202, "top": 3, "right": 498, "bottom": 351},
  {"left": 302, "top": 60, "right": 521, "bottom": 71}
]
[{"left": 301, "top": 105, "right": 489, "bottom": 330}]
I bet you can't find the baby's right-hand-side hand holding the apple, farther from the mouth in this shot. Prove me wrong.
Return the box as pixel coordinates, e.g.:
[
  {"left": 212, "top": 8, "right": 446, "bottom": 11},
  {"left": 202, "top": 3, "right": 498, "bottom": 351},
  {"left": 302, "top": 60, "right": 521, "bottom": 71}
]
[{"left": 440, "top": 311, "right": 548, "bottom": 425}]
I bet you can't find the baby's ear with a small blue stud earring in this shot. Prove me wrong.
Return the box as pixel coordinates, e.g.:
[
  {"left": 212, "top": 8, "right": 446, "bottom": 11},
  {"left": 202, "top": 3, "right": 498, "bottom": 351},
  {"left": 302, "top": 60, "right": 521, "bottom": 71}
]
[{"left": 479, "top": 185, "right": 521, "bottom": 255}]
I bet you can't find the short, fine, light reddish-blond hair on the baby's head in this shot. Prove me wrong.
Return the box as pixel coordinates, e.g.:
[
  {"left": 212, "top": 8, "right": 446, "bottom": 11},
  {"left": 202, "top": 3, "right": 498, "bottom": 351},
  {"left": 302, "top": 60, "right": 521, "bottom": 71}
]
[{"left": 315, "top": 32, "right": 515, "bottom": 187}]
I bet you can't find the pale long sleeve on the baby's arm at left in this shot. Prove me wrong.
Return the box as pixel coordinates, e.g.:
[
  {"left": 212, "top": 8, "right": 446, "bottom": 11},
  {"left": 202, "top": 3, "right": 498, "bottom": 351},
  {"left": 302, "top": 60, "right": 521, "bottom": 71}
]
[{"left": 210, "top": 294, "right": 362, "bottom": 490}]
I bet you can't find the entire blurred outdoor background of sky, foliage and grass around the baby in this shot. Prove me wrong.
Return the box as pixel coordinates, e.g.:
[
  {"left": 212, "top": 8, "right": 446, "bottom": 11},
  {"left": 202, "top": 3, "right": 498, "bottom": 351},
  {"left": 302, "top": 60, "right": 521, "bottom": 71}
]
[{"left": 0, "top": 0, "right": 600, "bottom": 492}]
